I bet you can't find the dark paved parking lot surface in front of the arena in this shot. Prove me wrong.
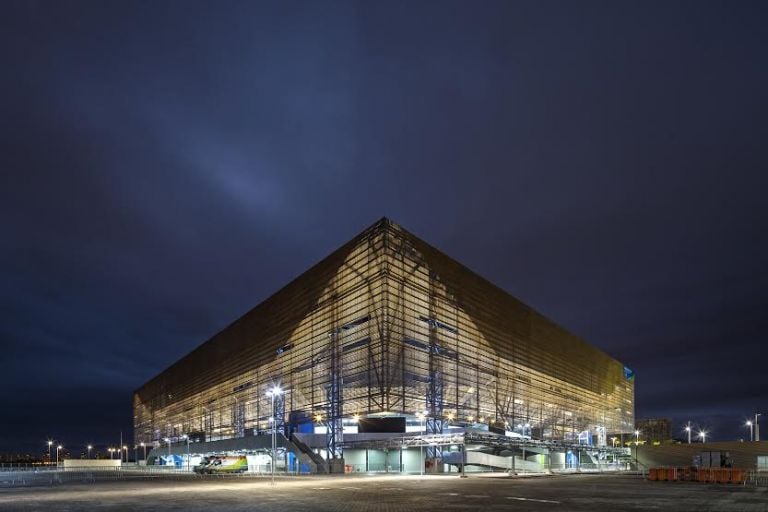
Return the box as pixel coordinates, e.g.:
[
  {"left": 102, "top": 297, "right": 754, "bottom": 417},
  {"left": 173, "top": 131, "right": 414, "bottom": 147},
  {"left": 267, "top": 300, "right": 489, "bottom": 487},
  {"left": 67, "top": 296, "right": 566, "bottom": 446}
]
[{"left": 0, "top": 475, "right": 768, "bottom": 512}]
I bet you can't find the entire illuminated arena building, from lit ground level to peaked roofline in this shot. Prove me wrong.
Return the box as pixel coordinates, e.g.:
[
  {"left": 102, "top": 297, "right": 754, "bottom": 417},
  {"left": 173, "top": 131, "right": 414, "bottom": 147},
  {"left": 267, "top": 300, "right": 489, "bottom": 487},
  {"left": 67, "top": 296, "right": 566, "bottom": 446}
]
[{"left": 133, "top": 219, "right": 634, "bottom": 472}]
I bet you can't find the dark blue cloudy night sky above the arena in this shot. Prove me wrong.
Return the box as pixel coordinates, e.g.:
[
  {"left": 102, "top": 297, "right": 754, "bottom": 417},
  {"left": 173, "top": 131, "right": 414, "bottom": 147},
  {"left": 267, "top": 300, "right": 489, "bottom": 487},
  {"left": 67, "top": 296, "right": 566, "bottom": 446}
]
[{"left": 0, "top": 0, "right": 768, "bottom": 452}]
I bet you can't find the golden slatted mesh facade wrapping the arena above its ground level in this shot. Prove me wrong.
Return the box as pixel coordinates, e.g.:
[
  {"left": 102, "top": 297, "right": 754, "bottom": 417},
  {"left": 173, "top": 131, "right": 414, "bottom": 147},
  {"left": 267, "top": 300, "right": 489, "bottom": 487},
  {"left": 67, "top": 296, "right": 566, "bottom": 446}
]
[{"left": 134, "top": 219, "right": 634, "bottom": 450}]
